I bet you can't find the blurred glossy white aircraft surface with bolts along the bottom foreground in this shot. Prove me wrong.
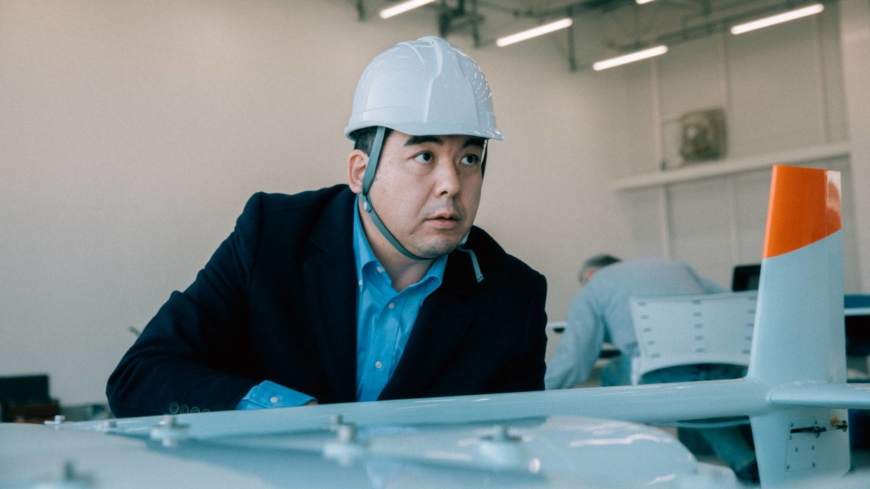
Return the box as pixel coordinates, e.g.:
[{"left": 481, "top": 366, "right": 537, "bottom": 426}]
[{"left": 0, "top": 412, "right": 739, "bottom": 489}]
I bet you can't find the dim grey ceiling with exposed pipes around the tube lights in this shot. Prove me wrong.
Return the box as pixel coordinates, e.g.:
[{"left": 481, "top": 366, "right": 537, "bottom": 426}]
[{"left": 348, "top": 0, "right": 835, "bottom": 70}]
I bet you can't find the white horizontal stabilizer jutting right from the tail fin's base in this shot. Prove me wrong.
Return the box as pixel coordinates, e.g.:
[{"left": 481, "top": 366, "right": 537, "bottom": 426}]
[{"left": 769, "top": 384, "right": 870, "bottom": 409}]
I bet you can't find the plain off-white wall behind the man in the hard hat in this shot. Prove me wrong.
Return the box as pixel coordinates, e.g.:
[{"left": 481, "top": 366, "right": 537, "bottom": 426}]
[{"left": 0, "top": 0, "right": 633, "bottom": 404}]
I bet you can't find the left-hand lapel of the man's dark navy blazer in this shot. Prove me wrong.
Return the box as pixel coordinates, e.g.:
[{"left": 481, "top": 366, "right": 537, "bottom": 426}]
[{"left": 303, "top": 190, "right": 357, "bottom": 402}]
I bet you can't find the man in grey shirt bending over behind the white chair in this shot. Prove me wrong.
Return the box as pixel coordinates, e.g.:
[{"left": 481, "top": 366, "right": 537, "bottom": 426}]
[{"left": 545, "top": 255, "right": 758, "bottom": 482}]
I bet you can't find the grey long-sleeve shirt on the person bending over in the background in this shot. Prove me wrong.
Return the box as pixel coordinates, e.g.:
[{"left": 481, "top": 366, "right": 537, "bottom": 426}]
[{"left": 544, "top": 258, "right": 724, "bottom": 389}]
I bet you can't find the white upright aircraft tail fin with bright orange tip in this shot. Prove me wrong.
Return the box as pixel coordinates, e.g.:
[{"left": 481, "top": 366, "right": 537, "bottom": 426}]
[{"left": 748, "top": 166, "right": 850, "bottom": 488}]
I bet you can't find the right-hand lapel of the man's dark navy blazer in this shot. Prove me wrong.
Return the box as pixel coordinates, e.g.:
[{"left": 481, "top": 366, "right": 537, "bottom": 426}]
[{"left": 378, "top": 252, "right": 476, "bottom": 400}]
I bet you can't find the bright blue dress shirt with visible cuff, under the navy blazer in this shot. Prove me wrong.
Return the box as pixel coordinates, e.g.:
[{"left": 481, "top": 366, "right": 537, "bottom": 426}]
[{"left": 236, "top": 195, "right": 447, "bottom": 409}]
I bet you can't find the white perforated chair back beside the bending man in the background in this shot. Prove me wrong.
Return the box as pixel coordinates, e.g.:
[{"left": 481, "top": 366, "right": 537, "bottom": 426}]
[{"left": 630, "top": 291, "right": 758, "bottom": 385}]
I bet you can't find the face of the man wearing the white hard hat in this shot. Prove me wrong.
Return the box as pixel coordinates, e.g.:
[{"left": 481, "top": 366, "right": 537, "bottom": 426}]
[{"left": 351, "top": 131, "right": 484, "bottom": 258}]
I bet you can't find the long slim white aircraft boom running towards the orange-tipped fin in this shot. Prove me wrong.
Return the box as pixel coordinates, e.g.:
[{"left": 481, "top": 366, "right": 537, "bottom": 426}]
[{"left": 64, "top": 379, "right": 772, "bottom": 439}]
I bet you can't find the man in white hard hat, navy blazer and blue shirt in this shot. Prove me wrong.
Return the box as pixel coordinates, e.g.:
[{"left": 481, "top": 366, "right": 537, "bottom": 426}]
[{"left": 107, "top": 37, "right": 546, "bottom": 416}]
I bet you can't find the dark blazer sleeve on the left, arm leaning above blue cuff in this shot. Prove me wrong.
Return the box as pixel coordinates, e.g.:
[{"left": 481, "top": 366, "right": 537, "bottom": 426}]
[{"left": 106, "top": 194, "right": 262, "bottom": 417}]
